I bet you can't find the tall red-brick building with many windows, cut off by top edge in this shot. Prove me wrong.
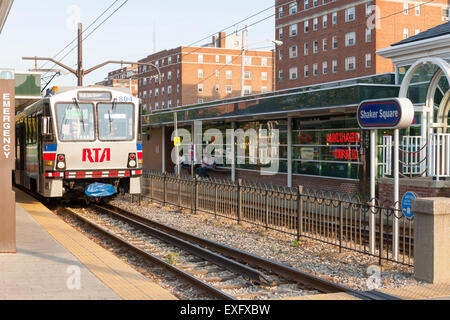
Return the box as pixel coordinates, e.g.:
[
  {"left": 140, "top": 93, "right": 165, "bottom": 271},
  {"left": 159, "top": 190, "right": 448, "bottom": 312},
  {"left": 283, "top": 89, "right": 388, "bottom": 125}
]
[{"left": 275, "top": 0, "right": 449, "bottom": 90}]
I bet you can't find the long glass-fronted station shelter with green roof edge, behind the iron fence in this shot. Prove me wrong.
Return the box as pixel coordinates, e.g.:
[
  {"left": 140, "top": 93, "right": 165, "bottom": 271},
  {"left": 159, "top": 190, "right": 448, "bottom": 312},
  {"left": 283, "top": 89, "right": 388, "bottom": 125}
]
[{"left": 143, "top": 23, "right": 450, "bottom": 200}]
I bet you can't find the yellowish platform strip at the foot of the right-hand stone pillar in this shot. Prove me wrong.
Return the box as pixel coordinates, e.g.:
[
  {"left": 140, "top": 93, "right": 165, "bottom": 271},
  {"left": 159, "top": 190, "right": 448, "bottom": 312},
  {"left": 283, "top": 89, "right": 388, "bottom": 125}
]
[{"left": 379, "top": 283, "right": 450, "bottom": 300}]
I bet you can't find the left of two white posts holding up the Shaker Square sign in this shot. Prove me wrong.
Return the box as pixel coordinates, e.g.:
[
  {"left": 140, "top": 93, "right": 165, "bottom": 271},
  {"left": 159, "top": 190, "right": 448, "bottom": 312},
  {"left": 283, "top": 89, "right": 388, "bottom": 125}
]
[{"left": 369, "top": 129, "right": 377, "bottom": 254}]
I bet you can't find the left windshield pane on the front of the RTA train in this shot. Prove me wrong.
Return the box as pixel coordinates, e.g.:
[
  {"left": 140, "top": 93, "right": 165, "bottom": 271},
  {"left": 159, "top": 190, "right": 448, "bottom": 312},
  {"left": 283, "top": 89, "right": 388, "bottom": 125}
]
[{"left": 56, "top": 100, "right": 95, "bottom": 141}]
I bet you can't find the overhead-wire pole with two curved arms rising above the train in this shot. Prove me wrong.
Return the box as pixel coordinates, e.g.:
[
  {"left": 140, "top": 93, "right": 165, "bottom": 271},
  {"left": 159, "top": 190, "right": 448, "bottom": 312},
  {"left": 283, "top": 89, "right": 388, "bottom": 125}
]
[{"left": 22, "top": 23, "right": 161, "bottom": 87}]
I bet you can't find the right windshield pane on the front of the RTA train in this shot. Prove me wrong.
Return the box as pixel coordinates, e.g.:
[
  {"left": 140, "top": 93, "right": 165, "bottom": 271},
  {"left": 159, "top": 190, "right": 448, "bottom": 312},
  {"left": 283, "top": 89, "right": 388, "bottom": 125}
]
[{"left": 97, "top": 102, "right": 134, "bottom": 141}]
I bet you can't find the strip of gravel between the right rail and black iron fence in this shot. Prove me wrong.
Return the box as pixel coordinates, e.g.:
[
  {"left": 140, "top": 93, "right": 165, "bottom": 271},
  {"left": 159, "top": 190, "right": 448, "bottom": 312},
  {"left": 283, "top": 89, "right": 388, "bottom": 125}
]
[{"left": 110, "top": 197, "right": 422, "bottom": 291}]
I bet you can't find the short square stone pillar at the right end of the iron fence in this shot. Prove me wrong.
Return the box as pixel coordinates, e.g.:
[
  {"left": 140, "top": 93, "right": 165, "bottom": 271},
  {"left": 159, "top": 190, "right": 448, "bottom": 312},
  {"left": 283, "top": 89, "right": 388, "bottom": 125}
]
[{"left": 412, "top": 198, "right": 450, "bottom": 283}]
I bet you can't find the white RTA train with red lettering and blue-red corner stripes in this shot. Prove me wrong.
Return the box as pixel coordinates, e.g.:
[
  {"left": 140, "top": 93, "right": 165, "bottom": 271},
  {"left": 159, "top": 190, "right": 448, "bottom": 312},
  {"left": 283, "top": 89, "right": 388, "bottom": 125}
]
[{"left": 14, "top": 87, "right": 143, "bottom": 200}]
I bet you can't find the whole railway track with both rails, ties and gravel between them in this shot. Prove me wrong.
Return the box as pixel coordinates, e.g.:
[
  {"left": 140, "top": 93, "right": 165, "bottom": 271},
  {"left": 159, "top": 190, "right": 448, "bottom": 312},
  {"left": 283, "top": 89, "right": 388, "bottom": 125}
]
[{"left": 58, "top": 205, "right": 400, "bottom": 300}]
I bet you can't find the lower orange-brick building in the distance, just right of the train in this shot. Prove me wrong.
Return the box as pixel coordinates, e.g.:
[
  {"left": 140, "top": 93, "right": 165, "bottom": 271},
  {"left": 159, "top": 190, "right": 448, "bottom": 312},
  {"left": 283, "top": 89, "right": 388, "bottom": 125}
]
[{"left": 139, "top": 33, "right": 274, "bottom": 111}]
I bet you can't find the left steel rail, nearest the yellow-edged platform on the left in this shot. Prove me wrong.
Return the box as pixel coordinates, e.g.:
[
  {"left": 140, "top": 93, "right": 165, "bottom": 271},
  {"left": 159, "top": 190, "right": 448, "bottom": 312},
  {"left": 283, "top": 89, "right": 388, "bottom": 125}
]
[{"left": 56, "top": 208, "right": 236, "bottom": 300}]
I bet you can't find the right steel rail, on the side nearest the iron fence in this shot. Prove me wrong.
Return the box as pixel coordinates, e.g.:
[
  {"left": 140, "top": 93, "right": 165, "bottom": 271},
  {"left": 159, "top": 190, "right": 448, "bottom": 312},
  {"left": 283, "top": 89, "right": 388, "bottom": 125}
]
[{"left": 93, "top": 204, "right": 395, "bottom": 300}]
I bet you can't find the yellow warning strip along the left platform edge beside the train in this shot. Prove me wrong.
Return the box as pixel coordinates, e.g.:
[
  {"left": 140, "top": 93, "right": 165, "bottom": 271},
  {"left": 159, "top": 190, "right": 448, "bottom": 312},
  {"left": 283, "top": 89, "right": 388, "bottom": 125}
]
[{"left": 15, "top": 190, "right": 176, "bottom": 300}]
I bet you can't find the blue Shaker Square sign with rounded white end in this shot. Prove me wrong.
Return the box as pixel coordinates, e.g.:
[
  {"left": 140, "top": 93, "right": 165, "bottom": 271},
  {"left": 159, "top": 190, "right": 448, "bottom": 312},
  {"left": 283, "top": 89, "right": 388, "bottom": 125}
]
[{"left": 358, "top": 98, "right": 414, "bottom": 130}]
